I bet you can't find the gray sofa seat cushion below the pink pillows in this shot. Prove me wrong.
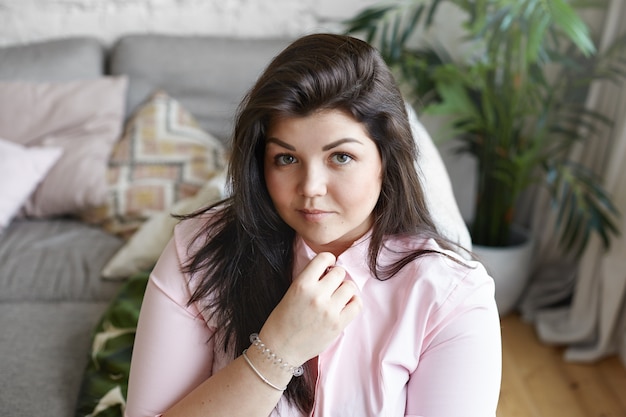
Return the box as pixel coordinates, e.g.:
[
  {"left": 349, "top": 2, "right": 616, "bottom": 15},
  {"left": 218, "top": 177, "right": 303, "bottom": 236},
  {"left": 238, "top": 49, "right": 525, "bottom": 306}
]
[{"left": 0, "top": 219, "right": 123, "bottom": 301}]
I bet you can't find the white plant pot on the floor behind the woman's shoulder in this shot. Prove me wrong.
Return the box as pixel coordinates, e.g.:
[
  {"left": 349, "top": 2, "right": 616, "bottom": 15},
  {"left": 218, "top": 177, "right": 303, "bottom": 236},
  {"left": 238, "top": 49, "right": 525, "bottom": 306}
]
[{"left": 473, "top": 228, "right": 534, "bottom": 317}]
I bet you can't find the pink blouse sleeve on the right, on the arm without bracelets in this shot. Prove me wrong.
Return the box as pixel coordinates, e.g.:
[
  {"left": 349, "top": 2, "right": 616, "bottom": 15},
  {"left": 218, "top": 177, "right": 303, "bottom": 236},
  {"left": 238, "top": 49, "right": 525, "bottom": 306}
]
[{"left": 406, "top": 268, "right": 502, "bottom": 417}]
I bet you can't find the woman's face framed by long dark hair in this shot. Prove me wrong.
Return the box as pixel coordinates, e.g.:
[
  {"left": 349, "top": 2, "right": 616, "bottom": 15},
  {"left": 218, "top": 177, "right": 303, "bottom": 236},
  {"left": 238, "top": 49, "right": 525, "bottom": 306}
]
[{"left": 264, "top": 110, "right": 382, "bottom": 256}]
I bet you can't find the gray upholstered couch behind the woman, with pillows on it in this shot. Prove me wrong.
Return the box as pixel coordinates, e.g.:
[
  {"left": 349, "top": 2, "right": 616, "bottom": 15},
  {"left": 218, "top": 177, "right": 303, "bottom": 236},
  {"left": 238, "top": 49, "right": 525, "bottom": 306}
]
[{"left": 0, "top": 35, "right": 287, "bottom": 417}]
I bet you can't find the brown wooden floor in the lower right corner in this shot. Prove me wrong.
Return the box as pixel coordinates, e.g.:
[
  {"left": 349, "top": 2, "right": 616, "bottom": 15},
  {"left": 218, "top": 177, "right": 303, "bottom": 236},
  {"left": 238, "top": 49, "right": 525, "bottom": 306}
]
[{"left": 498, "top": 315, "right": 626, "bottom": 417}]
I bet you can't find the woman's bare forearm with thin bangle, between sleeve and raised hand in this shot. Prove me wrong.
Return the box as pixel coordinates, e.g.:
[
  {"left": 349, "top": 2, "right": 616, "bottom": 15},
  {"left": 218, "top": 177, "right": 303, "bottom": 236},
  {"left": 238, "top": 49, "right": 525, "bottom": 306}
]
[{"left": 164, "top": 349, "right": 292, "bottom": 417}]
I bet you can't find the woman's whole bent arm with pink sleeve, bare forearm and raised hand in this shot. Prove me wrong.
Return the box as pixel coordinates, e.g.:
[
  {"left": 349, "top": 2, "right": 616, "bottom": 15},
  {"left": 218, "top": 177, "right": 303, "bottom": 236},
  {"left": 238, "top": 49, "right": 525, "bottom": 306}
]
[{"left": 132, "top": 250, "right": 361, "bottom": 417}]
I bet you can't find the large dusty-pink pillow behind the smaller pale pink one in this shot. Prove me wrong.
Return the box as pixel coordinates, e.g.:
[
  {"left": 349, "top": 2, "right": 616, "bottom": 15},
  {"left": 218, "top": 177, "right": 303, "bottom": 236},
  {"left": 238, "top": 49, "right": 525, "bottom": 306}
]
[{"left": 0, "top": 77, "right": 127, "bottom": 217}]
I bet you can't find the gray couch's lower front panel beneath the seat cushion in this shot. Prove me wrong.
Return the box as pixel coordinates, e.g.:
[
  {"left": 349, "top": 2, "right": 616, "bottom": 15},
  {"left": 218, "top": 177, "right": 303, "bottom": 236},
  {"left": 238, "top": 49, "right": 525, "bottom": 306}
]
[{"left": 0, "top": 302, "right": 108, "bottom": 417}]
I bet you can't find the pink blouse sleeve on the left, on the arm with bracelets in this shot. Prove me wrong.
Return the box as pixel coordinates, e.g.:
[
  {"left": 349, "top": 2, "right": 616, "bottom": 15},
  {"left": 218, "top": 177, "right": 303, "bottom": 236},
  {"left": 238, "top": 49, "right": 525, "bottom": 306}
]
[{"left": 125, "top": 240, "right": 214, "bottom": 417}]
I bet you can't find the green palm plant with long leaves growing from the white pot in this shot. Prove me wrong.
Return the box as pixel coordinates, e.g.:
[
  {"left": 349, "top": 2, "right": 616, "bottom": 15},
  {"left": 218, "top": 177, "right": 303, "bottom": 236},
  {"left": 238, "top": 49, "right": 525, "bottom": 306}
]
[{"left": 344, "top": 0, "right": 626, "bottom": 312}]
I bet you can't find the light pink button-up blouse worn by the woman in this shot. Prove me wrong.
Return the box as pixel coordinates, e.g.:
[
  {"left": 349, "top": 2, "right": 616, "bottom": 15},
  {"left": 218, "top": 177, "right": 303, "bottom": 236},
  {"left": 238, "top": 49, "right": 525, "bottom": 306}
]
[{"left": 125, "top": 213, "right": 501, "bottom": 417}]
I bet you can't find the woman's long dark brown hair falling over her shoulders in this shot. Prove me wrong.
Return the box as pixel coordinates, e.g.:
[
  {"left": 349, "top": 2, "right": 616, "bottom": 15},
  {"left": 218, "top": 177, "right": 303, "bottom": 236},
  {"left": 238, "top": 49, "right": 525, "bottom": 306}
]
[{"left": 180, "top": 34, "right": 450, "bottom": 412}]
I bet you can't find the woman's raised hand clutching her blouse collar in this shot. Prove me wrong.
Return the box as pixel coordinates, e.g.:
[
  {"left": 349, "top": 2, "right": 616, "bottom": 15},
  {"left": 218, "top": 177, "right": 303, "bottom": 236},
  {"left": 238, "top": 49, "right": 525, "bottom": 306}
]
[{"left": 259, "top": 252, "right": 362, "bottom": 366}]
